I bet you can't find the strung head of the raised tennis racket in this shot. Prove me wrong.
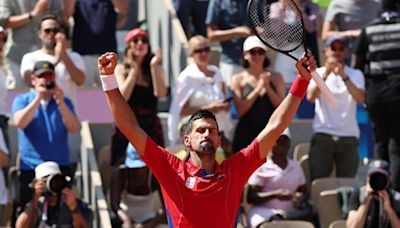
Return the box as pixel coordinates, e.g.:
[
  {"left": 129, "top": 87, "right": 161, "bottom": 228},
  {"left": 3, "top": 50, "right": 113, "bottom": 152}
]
[{"left": 248, "top": 0, "right": 304, "bottom": 51}]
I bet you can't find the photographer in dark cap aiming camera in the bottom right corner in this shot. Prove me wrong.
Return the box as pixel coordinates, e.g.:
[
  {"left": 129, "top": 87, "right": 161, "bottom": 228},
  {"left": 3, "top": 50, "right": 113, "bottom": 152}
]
[{"left": 347, "top": 160, "right": 400, "bottom": 228}]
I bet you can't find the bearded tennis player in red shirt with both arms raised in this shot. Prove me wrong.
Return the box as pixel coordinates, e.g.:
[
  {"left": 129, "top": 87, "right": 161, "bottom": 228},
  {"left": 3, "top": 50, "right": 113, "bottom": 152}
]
[{"left": 98, "top": 52, "right": 316, "bottom": 227}]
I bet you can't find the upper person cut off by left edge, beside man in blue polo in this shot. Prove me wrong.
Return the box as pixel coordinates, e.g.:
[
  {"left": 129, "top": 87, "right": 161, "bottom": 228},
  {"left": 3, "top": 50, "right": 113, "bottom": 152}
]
[{"left": 0, "top": 26, "right": 10, "bottom": 148}]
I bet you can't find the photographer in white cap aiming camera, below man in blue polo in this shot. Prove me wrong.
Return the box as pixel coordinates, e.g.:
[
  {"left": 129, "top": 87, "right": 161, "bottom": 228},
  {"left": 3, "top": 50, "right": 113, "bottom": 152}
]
[{"left": 16, "top": 161, "right": 87, "bottom": 228}]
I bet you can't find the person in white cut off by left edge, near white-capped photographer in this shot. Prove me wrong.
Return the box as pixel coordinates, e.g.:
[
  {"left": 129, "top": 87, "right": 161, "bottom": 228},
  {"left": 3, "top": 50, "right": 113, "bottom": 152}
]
[{"left": 0, "top": 131, "right": 9, "bottom": 226}]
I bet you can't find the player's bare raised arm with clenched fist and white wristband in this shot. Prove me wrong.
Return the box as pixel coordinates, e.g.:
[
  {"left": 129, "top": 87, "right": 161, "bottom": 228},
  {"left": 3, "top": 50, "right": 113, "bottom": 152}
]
[{"left": 98, "top": 52, "right": 148, "bottom": 156}]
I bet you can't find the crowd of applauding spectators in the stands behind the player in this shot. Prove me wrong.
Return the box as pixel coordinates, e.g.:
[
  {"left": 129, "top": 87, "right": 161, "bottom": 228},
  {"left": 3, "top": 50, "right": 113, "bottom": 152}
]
[{"left": 0, "top": 0, "right": 400, "bottom": 227}]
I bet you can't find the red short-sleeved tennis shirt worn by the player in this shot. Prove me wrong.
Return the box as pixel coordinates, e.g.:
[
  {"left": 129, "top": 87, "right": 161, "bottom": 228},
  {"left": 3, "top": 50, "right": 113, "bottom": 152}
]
[{"left": 143, "top": 137, "right": 265, "bottom": 228}]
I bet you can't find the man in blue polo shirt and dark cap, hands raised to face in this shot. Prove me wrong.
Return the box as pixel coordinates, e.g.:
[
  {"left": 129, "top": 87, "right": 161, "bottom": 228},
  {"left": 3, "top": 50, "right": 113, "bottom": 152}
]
[{"left": 12, "top": 61, "right": 80, "bottom": 212}]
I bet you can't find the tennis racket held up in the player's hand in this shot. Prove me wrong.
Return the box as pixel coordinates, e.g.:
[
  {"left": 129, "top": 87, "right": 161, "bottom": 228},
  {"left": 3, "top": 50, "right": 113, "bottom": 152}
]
[{"left": 247, "top": 0, "right": 336, "bottom": 107}]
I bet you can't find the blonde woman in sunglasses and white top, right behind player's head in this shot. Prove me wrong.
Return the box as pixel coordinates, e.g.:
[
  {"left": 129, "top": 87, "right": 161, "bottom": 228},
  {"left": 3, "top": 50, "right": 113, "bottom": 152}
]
[{"left": 168, "top": 36, "right": 232, "bottom": 145}]
